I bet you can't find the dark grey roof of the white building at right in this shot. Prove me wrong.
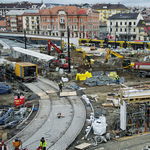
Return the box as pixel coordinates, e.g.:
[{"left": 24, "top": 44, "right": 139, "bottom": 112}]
[{"left": 107, "top": 13, "right": 139, "bottom": 20}]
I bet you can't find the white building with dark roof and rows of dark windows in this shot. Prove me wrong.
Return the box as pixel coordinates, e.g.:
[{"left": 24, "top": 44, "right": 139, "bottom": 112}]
[{"left": 107, "top": 13, "right": 143, "bottom": 41}]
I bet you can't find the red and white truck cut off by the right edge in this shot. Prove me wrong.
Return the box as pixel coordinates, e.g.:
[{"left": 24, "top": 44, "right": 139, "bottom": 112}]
[{"left": 133, "top": 62, "right": 150, "bottom": 78}]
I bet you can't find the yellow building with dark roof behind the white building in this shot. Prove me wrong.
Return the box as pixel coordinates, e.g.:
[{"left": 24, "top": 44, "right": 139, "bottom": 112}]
[{"left": 92, "top": 3, "right": 130, "bottom": 23}]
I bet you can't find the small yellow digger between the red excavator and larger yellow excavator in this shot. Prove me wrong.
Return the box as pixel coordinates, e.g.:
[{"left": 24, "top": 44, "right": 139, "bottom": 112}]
[{"left": 83, "top": 51, "right": 94, "bottom": 66}]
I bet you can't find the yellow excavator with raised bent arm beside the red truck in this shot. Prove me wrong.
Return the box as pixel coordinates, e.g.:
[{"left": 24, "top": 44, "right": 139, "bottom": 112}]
[{"left": 105, "top": 49, "right": 134, "bottom": 69}]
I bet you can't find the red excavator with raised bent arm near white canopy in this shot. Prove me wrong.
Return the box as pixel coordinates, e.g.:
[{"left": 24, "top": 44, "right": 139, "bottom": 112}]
[{"left": 47, "top": 40, "right": 68, "bottom": 68}]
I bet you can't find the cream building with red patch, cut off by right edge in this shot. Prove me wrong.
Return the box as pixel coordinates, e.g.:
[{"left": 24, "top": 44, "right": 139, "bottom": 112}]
[{"left": 136, "top": 20, "right": 150, "bottom": 41}]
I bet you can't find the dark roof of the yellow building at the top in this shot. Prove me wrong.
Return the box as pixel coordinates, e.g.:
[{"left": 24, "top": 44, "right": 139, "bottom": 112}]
[{"left": 92, "top": 3, "right": 128, "bottom": 9}]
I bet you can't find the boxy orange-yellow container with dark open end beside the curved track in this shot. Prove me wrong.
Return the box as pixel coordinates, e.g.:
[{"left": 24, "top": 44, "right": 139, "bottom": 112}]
[{"left": 15, "top": 62, "right": 38, "bottom": 81}]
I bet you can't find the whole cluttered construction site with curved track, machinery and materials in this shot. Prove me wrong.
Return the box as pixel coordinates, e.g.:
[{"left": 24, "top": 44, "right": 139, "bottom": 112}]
[{"left": 0, "top": 37, "right": 150, "bottom": 150}]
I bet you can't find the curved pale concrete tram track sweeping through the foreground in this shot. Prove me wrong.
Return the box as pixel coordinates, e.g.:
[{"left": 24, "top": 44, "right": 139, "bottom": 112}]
[{"left": 7, "top": 78, "right": 86, "bottom": 150}]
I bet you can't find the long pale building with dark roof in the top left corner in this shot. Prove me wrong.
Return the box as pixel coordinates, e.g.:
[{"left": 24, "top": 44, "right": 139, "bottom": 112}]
[{"left": 0, "top": 1, "right": 46, "bottom": 17}]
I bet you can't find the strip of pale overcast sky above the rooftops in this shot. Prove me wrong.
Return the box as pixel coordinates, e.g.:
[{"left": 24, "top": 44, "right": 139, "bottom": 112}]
[{"left": 0, "top": 0, "right": 150, "bottom": 7}]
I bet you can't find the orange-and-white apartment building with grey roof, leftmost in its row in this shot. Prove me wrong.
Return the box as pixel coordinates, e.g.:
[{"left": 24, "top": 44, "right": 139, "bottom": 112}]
[{"left": 5, "top": 10, "right": 24, "bottom": 32}]
